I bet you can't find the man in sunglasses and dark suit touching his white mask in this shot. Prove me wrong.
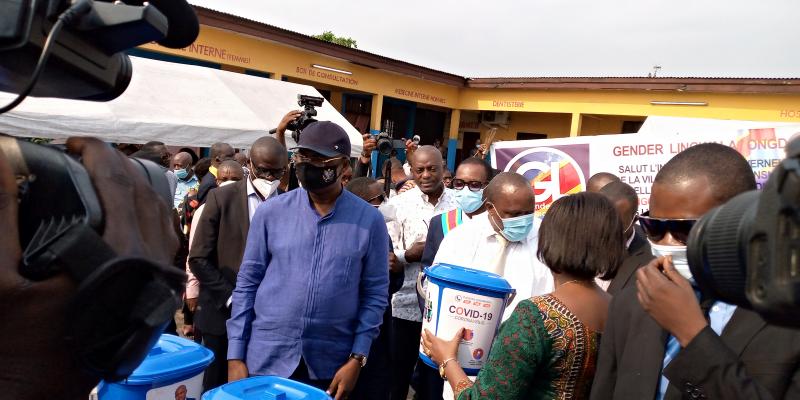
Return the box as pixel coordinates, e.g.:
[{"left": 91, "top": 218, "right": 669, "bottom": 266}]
[{"left": 591, "top": 143, "right": 800, "bottom": 400}]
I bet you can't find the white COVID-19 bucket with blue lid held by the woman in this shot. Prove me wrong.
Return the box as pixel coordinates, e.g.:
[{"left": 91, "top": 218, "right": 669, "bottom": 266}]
[{"left": 419, "top": 264, "right": 515, "bottom": 375}]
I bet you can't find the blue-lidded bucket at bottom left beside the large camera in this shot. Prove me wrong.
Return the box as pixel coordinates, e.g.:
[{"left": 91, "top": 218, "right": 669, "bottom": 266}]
[{"left": 97, "top": 335, "right": 214, "bottom": 400}]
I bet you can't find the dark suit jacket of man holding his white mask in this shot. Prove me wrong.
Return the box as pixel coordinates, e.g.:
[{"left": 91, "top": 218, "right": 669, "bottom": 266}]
[{"left": 591, "top": 287, "right": 800, "bottom": 400}]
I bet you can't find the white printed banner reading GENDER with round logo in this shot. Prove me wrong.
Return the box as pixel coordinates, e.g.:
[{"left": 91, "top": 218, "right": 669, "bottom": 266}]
[{"left": 491, "top": 125, "right": 800, "bottom": 217}]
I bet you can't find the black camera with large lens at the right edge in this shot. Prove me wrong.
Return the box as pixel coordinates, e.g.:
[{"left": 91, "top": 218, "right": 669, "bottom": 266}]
[{"left": 687, "top": 139, "right": 800, "bottom": 327}]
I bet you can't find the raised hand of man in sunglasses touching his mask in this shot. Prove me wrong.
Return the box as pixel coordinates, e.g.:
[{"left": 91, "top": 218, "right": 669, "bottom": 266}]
[{"left": 636, "top": 257, "right": 708, "bottom": 347}]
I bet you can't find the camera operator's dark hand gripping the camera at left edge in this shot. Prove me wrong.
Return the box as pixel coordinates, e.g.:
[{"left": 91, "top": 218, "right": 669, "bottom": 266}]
[{"left": 0, "top": 139, "right": 178, "bottom": 400}]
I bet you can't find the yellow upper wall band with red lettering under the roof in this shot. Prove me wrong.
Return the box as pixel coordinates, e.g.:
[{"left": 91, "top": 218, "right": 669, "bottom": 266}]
[{"left": 142, "top": 25, "right": 800, "bottom": 127}]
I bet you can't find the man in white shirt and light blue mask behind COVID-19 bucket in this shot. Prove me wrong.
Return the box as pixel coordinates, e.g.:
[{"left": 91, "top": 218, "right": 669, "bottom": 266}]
[{"left": 433, "top": 172, "right": 553, "bottom": 399}]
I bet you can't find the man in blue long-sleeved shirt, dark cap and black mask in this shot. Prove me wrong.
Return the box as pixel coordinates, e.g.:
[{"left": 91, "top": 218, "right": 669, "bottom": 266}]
[{"left": 227, "top": 121, "right": 389, "bottom": 399}]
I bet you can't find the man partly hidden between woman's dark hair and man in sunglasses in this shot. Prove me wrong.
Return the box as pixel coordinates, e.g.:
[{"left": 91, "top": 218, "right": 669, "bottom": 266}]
[{"left": 598, "top": 181, "right": 653, "bottom": 295}]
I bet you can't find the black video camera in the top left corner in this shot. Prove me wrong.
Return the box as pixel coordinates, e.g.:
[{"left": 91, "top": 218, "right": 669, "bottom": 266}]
[{"left": 0, "top": 0, "right": 199, "bottom": 101}]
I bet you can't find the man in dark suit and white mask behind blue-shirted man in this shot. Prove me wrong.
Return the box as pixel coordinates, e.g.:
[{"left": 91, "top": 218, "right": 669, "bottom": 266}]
[{"left": 189, "top": 137, "right": 289, "bottom": 391}]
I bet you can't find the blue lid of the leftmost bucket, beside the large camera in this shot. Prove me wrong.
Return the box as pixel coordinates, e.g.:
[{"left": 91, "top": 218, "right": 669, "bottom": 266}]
[{"left": 123, "top": 335, "right": 214, "bottom": 385}]
